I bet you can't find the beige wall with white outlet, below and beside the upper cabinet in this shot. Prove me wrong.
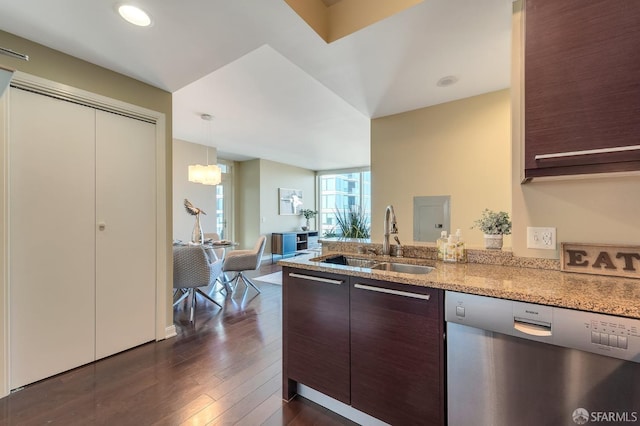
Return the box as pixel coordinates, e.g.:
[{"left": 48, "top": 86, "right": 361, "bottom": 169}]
[{"left": 512, "top": 1, "right": 640, "bottom": 258}]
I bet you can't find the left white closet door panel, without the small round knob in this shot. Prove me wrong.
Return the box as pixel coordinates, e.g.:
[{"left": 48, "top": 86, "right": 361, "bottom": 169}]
[{"left": 9, "top": 88, "right": 95, "bottom": 389}]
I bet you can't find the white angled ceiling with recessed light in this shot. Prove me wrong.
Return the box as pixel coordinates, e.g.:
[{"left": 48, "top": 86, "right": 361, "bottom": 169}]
[{"left": 0, "top": 0, "right": 512, "bottom": 170}]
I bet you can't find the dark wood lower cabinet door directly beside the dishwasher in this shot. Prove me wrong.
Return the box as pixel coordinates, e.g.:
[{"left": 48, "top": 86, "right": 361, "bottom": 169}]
[{"left": 351, "top": 277, "right": 445, "bottom": 425}]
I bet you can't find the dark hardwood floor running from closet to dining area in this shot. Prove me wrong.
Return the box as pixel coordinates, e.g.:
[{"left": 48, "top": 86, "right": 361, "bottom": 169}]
[{"left": 0, "top": 265, "right": 355, "bottom": 426}]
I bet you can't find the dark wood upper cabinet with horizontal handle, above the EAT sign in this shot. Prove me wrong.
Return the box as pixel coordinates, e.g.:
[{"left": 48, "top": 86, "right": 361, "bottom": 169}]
[{"left": 524, "top": 0, "right": 640, "bottom": 180}]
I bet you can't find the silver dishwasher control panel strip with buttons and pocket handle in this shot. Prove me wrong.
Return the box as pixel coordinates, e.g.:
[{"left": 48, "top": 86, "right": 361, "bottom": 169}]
[{"left": 445, "top": 291, "right": 640, "bottom": 363}]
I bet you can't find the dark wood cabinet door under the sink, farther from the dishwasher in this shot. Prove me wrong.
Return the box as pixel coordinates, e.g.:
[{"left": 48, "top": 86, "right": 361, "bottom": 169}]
[{"left": 283, "top": 268, "right": 349, "bottom": 404}]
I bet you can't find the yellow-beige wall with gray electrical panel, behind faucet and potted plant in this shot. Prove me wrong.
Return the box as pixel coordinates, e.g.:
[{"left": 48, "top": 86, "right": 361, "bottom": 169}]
[{"left": 371, "top": 90, "right": 511, "bottom": 247}]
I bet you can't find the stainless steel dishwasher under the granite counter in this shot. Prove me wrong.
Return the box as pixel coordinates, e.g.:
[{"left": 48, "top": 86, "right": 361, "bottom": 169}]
[{"left": 445, "top": 291, "right": 640, "bottom": 426}]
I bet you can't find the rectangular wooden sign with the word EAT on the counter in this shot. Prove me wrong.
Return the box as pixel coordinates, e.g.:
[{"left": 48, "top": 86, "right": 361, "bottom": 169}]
[{"left": 560, "top": 243, "right": 640, "bottom": 278}]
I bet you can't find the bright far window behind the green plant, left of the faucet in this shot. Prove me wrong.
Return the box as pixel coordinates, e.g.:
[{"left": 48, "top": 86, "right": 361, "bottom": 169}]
[{"left": 318, "top": 169, "right": 371, "bottom": 236}]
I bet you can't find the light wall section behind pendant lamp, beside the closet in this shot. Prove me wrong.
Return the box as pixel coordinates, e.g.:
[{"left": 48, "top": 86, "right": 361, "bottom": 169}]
[{"left": 173, "top": 139, "right": 217, "bottom": 241}]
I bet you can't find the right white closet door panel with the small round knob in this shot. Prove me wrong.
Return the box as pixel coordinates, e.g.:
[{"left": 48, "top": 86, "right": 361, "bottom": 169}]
[{"left": 96, "top": 111, "right": 156, "bottom": 359}]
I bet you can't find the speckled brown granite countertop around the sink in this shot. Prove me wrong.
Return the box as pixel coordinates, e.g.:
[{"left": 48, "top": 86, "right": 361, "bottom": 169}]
[{"left": 278, "top": 253, "right": 640, "bottom": 319}]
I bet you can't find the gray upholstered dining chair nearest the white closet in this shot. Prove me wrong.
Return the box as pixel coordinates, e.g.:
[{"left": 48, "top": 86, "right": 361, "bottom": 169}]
[{"left": 173, "top": 245, "right": 223, "bottom": 322}]
